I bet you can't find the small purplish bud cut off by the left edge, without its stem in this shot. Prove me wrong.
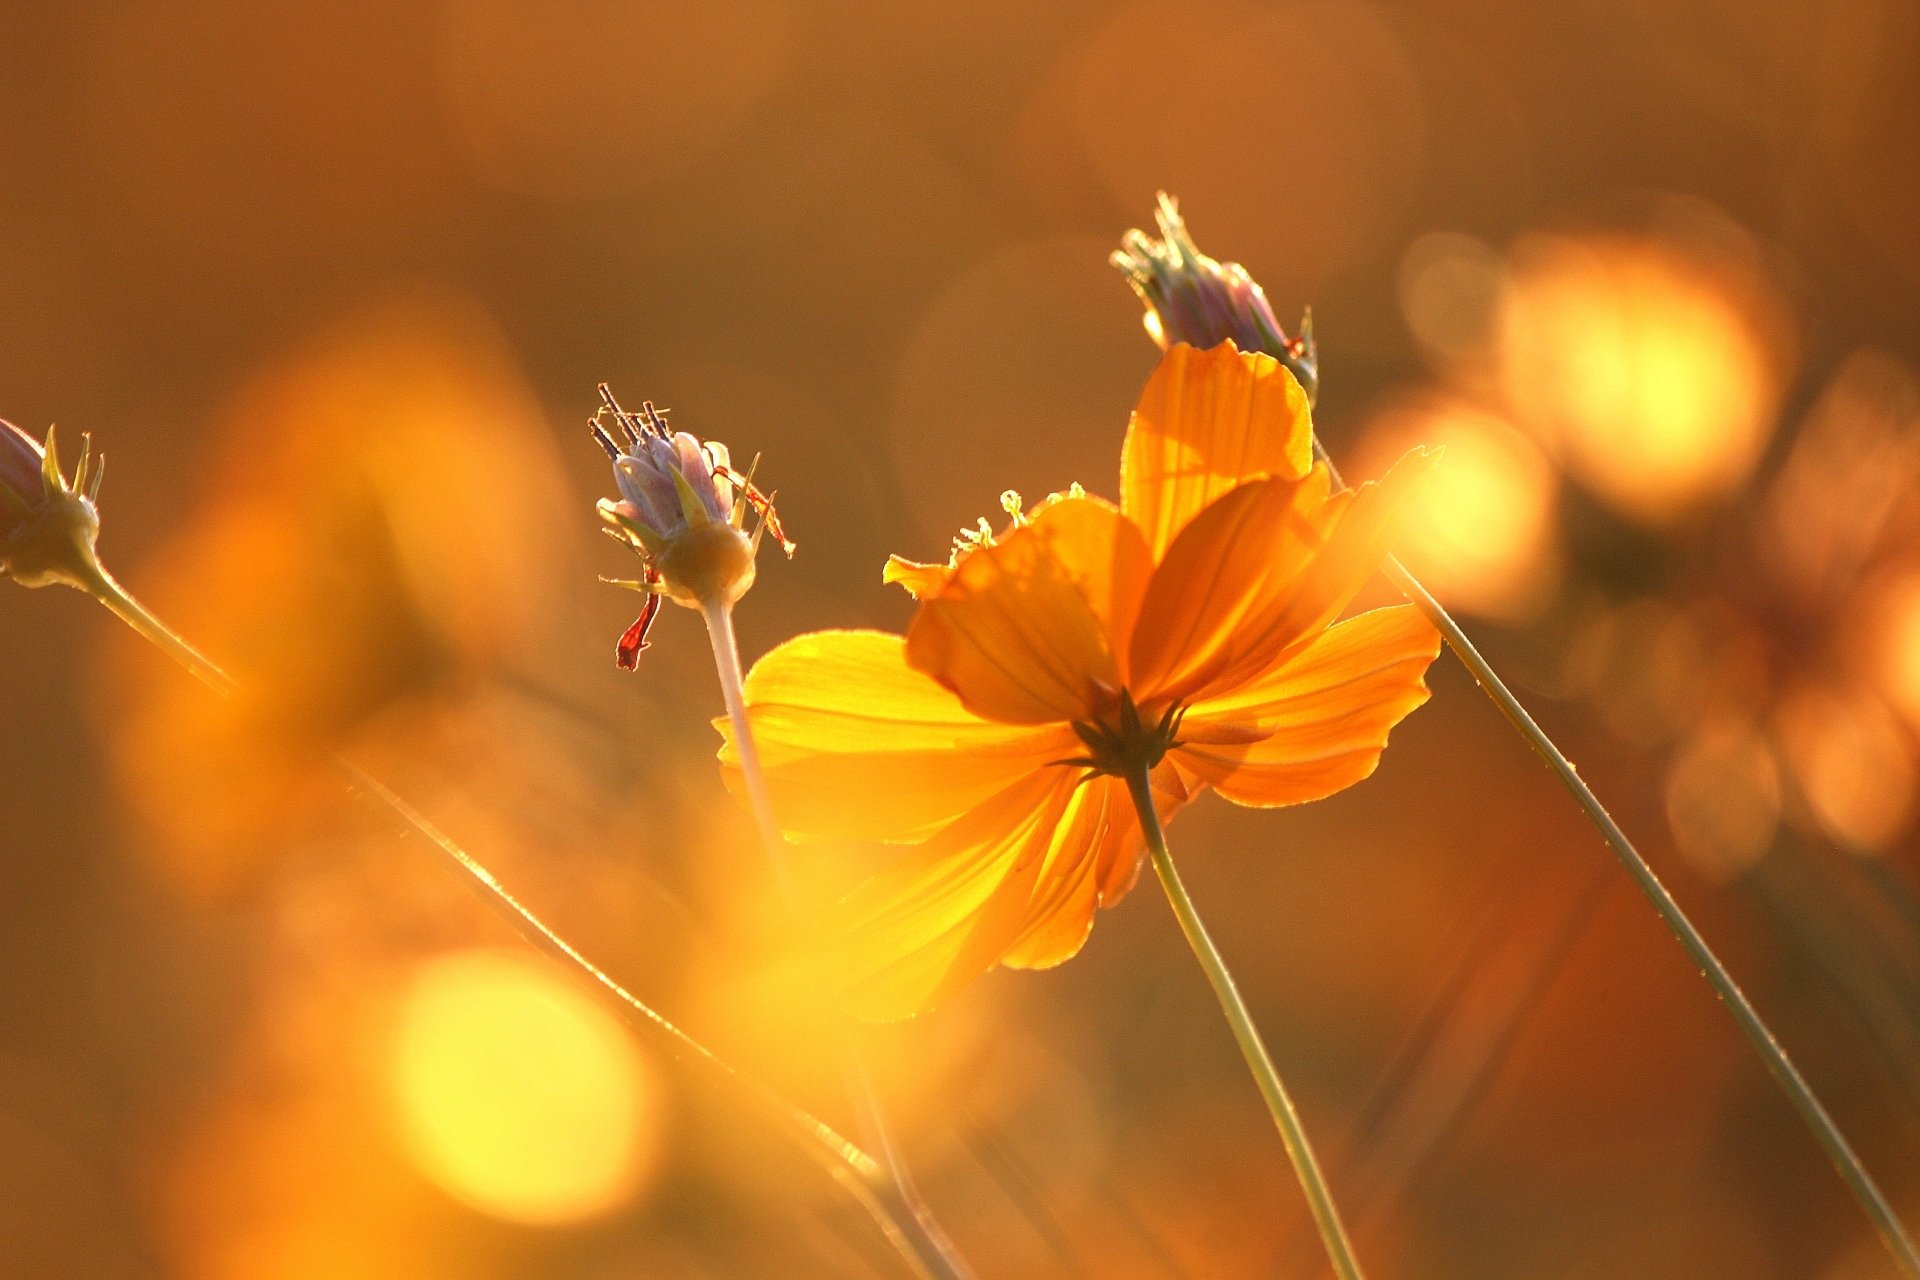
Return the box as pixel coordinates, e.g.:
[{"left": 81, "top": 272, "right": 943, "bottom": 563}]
[{"left": 0, "top": 422, "right": 106, "bottom": 587}]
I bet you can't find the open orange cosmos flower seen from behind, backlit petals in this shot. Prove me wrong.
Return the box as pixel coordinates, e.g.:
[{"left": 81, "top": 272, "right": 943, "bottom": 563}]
[{"left": 720, "top": 344, "right": 1440, "bottom": 1019}]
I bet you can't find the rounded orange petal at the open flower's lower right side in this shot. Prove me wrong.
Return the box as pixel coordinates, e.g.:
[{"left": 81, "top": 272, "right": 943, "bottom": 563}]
[{"left": 1173, "top": 604, "right": 1440, "bottom": 808}]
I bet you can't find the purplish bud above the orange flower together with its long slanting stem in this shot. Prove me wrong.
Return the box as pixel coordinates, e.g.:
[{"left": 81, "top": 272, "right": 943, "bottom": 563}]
[{"left": 1112, "top": 192, "right": 1920, "bottom": 1280}]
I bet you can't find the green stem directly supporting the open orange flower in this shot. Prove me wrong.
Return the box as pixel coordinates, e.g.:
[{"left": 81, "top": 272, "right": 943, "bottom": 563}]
[{"left": 1127, "top": 766, "right": 1361, "bottom": 1280}]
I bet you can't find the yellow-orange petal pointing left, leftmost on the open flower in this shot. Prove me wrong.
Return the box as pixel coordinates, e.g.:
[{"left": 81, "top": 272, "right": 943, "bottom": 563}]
[{"left": 714, "top": 631, "right": 1081, "bottom": 841}]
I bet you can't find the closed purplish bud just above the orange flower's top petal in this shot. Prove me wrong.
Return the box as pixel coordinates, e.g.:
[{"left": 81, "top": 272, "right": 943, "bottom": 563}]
[{"left": 1108, "top": 192, "right": 1319, "bottom": 401}]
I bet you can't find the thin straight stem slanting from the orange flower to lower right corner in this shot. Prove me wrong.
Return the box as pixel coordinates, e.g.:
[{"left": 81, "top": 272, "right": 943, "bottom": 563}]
[{"left": 1313, "top": 438, "right": 1920, "bottom": 1280}]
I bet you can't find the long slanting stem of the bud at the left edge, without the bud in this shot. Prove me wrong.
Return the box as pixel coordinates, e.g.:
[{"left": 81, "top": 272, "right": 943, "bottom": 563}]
[{"left": 79, "top": 560, "right": 947, "bottom": 1280}]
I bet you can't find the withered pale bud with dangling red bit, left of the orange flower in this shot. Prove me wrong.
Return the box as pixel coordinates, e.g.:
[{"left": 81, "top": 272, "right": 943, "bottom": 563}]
[{"left": 591, "top": 386, "right": 793, "bottom": 670}]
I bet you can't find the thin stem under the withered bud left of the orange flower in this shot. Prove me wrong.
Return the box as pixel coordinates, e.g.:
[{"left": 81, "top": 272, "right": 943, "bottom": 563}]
[{"left": 701, "top": 604, "right": 973, "bottom": 1280}]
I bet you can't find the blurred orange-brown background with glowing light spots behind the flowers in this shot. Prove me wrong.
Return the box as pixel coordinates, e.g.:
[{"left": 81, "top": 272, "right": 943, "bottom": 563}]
[{"left": 0, "top": 0, "right": 1920, "bottom": 1280}]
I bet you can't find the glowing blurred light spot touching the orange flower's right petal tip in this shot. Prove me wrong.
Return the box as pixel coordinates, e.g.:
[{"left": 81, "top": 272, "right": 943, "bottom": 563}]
[{"left": 1359, "top": 401, "right": 1559, "bottom": 622}]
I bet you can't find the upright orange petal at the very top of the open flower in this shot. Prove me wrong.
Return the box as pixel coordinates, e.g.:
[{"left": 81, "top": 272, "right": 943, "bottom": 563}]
[{"left": 1119, "top": 342, "right": 1313, "bottom": 560}]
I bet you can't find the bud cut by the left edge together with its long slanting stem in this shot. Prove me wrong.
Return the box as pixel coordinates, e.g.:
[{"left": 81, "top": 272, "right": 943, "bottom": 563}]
[{"left": 0, "top": 433, "right": 945, "bottom": 1280}]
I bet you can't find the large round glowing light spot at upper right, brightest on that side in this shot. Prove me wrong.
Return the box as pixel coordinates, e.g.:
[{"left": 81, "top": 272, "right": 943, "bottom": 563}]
[{"left": 1498, "top": 238, "right": 1780, "bottom": 524}]
